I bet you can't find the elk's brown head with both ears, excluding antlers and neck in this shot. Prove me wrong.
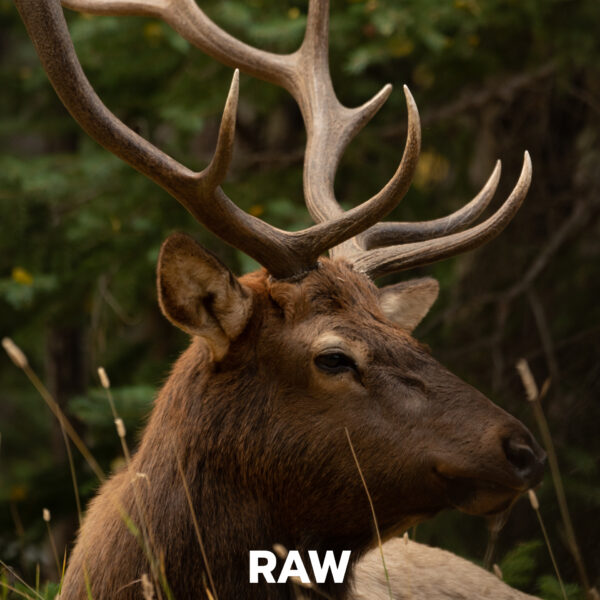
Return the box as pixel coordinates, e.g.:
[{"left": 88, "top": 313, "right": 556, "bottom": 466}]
[{"left": 158, "top": 234, "right": 542, "bottom": 528}]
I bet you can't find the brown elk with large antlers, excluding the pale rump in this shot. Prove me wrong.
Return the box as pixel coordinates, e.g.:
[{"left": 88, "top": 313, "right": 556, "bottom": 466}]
[{"left": 15, "top": 0, "right": 544, "bottom": 600}]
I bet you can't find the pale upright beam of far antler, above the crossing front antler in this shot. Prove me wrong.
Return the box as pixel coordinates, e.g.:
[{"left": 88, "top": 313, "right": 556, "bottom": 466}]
[{"left": 63, "top": 0, "right": 408, "bottom": 237}]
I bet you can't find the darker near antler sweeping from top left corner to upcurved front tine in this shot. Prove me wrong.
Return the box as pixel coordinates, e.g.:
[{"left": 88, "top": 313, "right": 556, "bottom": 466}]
[{"left": 15, "top": 0, "right": 420, "bottom": 278}]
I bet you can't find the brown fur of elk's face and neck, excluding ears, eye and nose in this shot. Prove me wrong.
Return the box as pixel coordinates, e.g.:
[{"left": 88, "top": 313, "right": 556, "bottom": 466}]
[{"left": 61, "top": 259, "right": 541, "bottom": 600}]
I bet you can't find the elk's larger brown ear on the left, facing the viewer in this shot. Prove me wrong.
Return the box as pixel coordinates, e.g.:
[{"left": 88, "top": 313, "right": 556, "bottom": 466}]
[{"left": 157, "top": 233, "right": 252, "bottom": 361}]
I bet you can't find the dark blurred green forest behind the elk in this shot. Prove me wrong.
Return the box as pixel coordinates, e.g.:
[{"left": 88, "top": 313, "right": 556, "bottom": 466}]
[{"left": 0, "top": 0, "right": 600, "bottom": 598}]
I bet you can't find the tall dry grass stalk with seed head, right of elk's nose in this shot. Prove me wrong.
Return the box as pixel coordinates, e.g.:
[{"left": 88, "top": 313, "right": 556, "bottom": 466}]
[{"left": 517, "top": 359, "right": 598, "bottom": 600}]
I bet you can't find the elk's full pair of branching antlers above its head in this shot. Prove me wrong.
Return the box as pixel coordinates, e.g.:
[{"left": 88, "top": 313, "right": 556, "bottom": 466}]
[{"left": 15, "top": 0, "right": 530, "bottom": 278}]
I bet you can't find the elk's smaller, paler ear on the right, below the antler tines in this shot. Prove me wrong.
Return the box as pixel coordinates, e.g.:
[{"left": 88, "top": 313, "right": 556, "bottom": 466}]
[{"left": 379, "top": 277, "right": 440, "bottom": 332}]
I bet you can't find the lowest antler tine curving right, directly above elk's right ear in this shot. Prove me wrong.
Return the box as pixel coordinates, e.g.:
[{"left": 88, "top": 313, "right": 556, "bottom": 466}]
[{"left": 352, "top": 152, "right": 532, "bottom": 278}]
